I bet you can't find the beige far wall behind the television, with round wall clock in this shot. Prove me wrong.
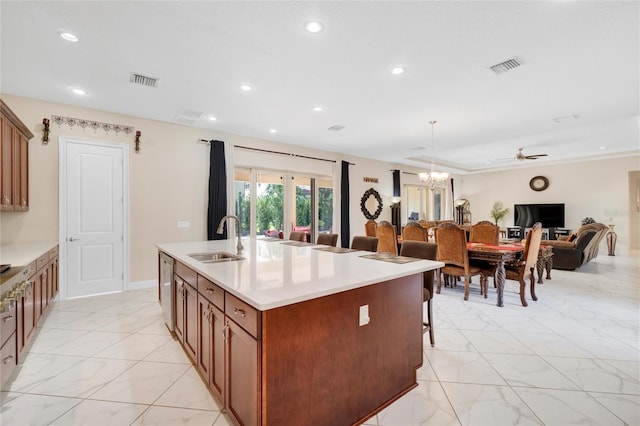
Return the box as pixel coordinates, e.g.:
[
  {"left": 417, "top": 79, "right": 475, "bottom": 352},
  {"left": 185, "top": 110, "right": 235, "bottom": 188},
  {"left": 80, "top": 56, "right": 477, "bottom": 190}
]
[{"left": 456, "top": 156, "right": 640, "bottom": 255}]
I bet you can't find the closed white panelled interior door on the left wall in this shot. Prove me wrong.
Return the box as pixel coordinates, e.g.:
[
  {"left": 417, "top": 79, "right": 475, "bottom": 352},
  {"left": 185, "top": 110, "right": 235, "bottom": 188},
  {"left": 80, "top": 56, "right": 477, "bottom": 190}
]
[{"left": 63, "top": 141, "right": 125, "bottom": 298}]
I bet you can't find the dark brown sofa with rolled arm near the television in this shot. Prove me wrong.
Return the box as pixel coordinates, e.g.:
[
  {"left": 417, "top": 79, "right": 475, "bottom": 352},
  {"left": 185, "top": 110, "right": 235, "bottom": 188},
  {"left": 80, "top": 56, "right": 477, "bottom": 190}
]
[{"left": 541, "top": 223, "right": 609, "bottom": 271}]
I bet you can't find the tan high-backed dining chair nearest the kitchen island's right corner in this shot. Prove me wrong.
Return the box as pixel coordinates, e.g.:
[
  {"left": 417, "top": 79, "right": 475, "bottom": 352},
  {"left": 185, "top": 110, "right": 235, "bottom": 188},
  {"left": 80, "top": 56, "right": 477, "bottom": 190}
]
[{"left": 435, "top": 222, "right": 487, "bottom": 300}]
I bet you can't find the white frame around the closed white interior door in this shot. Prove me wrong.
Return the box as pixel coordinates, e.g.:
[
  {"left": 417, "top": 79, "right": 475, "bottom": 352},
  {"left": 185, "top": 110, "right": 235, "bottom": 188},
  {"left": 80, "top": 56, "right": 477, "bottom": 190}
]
[{"left": 58, "top": 136, "right": 129, "bottom": 300}]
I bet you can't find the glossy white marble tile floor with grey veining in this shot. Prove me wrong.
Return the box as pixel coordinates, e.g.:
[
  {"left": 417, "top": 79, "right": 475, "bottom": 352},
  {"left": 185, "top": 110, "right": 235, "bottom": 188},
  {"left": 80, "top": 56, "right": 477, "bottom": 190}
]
[{"left": 0, "top": 254, "right": 640, "bottom": 426}]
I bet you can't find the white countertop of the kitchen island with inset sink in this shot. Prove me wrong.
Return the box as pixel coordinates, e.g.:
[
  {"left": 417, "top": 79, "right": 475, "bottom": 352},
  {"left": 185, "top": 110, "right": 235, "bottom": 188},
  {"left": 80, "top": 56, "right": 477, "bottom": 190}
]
[{"left": 157, "top": 239, "right": 444, "bottom": 310}]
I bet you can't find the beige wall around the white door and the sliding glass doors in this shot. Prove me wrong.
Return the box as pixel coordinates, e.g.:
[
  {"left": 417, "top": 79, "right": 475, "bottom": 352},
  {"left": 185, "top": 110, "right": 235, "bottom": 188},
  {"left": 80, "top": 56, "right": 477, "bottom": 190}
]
[{"left": 0, "top": 94, "right": 416, "bottom": 282}]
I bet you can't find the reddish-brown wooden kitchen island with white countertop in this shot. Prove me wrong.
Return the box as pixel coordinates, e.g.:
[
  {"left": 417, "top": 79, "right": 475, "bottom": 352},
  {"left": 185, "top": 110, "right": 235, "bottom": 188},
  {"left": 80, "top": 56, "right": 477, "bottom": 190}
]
[{"left": 157, "top": 239, "right": 442, "bottom": 425}]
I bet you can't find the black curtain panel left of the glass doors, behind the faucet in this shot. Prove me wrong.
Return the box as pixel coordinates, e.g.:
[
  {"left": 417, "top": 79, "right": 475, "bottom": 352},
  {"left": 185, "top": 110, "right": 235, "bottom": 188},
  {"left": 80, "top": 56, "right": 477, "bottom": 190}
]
[{"left": 207, "top": 141, "right": 227, "bottom": 240}]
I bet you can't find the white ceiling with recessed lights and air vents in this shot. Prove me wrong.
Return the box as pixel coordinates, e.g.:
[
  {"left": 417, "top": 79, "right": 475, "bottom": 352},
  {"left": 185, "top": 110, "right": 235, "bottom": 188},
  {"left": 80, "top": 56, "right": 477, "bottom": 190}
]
[{"left": 0, "top": 1, "right": 640, "bottom": 173}]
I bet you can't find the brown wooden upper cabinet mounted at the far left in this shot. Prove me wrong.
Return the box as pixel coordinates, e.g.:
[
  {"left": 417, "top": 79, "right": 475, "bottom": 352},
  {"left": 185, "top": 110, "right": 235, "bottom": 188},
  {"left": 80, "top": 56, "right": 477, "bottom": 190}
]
[{"left": 0, "top": 99, "right": 33, "bottom": 211}]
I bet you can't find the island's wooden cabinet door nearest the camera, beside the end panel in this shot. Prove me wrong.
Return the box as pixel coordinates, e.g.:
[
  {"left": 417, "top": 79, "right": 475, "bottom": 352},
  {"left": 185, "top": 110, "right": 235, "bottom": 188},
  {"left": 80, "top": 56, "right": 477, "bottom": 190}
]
[{"left": 225, "top": 319, "right": 261, "bottom": 425}]
